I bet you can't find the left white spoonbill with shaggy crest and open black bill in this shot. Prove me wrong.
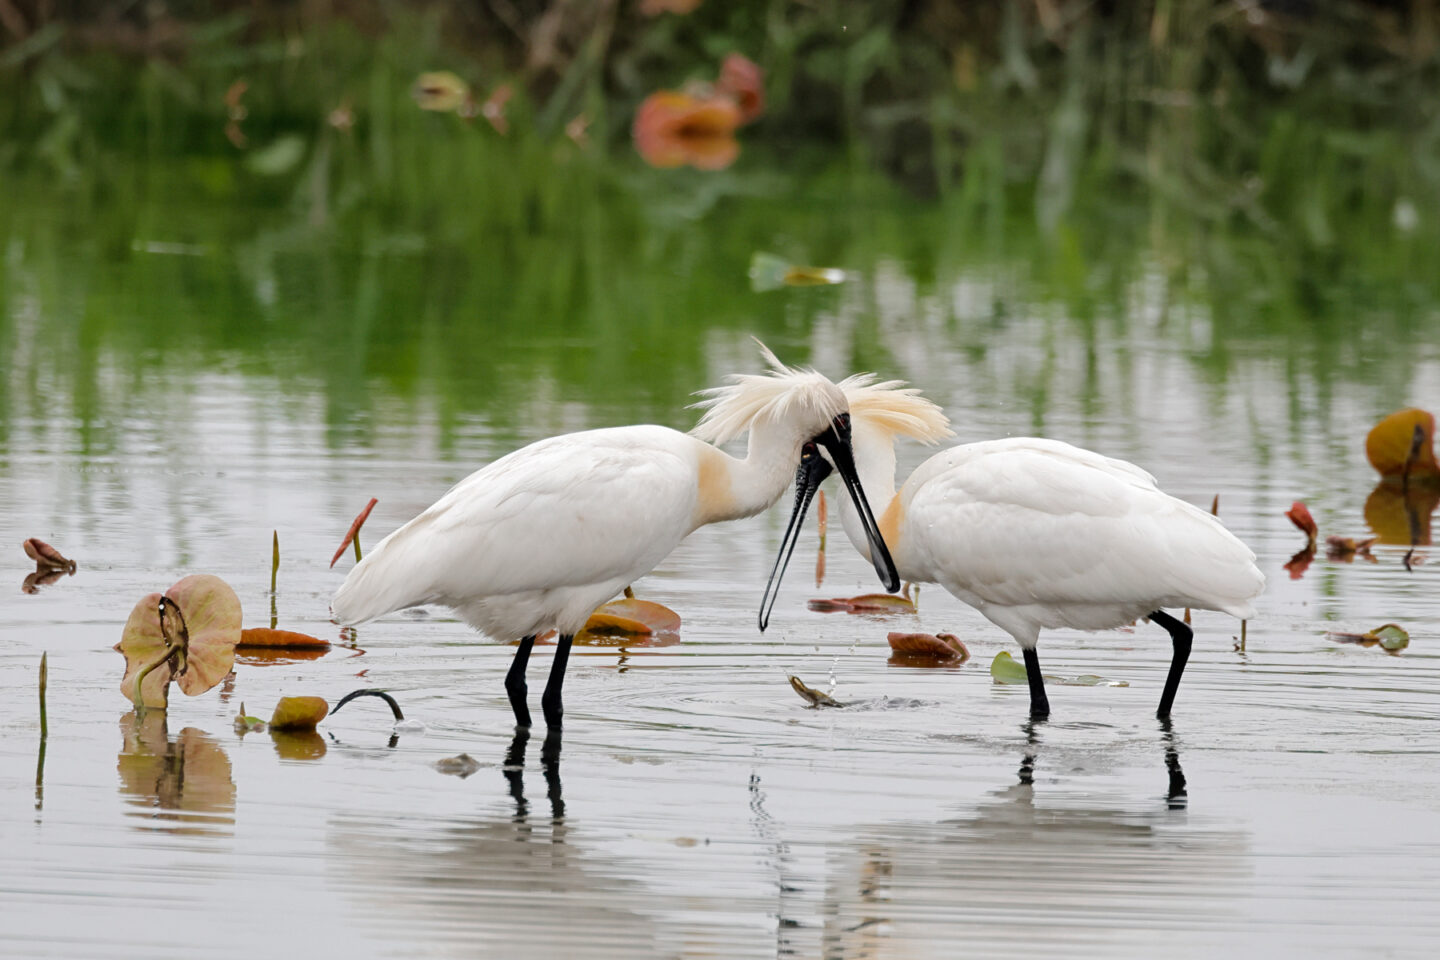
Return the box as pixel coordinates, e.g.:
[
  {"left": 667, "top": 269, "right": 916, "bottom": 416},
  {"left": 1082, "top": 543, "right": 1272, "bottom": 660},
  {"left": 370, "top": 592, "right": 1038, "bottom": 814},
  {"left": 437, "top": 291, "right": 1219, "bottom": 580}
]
[{"left": 331, "top": 344, "right": 900, "bottom": 727}]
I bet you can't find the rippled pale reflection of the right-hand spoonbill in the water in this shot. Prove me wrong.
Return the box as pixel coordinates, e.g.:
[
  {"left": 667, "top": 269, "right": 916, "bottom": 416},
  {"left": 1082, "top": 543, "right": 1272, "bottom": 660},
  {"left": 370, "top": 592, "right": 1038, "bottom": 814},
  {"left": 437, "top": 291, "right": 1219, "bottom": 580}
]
[{"left": 817, "top": 723, "right": 1253, "bottom": 960}]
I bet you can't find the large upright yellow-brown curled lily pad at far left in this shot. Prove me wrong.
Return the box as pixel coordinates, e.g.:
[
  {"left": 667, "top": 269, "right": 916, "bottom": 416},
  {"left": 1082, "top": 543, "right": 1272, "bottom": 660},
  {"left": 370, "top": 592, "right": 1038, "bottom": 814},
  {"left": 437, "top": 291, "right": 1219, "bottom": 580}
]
[{"left": 115, "top": 574, "right": 240, "bottom": 710}]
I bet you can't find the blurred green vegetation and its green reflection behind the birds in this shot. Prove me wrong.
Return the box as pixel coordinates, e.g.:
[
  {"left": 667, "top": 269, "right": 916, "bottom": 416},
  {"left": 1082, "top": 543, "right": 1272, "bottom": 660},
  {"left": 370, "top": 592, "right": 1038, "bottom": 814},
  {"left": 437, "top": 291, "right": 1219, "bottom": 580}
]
[{"left": 0, "top": 0, "right": 1440, "bottom": 451}]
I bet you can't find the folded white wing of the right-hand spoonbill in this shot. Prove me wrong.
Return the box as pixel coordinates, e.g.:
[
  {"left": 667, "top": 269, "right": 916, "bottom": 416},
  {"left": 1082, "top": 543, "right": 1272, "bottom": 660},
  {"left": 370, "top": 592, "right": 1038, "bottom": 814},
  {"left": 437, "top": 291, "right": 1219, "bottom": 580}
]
[{"left": 901, "top": 439, "right": 1263, "bottom": 612}]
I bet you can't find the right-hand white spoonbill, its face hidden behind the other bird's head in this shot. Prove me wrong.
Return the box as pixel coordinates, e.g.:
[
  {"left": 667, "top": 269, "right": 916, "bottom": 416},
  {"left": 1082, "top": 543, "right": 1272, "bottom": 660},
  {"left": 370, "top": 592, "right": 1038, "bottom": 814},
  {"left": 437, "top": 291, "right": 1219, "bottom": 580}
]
[{"left": 796, "top": 374, "right": 1264, "bottom": 718}]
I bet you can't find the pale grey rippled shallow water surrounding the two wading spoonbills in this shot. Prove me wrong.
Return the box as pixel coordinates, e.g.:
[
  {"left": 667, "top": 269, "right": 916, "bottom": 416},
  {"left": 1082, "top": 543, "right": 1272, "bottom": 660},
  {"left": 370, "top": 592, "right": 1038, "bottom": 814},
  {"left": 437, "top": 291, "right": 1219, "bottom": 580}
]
[{"left": 0, "top": 174, "right": 1440, "bottom": 959}]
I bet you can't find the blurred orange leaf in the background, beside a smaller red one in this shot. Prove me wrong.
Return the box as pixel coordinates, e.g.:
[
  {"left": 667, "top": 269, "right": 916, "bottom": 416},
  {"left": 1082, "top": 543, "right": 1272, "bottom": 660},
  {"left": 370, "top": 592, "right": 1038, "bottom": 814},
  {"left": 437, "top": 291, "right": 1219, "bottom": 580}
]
[{"left": 631, "top": 91, "right": 743, "bottom": 170}]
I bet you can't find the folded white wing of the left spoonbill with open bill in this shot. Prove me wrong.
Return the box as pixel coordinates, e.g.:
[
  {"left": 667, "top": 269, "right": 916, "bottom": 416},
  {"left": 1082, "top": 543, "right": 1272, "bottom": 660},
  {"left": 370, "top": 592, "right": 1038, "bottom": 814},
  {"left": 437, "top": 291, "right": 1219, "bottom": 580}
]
[{"left": 334, "top": 427, "right": 696, "bottom": 622}]
